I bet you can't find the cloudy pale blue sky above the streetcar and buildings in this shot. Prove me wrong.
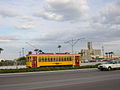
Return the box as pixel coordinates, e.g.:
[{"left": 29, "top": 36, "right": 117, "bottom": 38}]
[{"left": 0, "top": 0, "right": 120, "bottom": 59}]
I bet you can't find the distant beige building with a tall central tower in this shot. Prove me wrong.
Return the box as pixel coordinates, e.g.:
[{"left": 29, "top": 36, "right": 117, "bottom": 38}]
[{"left": 81, "top": 42, "right": 101, "bottom": 60}]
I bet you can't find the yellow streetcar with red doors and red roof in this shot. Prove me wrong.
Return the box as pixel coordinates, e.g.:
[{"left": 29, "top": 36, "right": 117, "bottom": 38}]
[{"left": 26, "top": 53, "right": 81, "bottom": 68}]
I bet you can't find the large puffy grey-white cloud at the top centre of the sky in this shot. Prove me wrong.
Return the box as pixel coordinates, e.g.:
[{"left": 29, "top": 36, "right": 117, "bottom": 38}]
[{"left": 34, "top": 0, "right": 89, "bottom": 21}]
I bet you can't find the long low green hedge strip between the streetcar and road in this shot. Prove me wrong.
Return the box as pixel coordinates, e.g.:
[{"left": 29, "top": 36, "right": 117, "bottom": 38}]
[{"left": 0, "top": 64, "right": 99, "bottom": 73}]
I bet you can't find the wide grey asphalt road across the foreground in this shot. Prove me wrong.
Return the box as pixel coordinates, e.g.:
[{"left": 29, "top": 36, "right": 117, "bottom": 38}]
[{"left": 0, "top": 69, "right": 120, "bottom": 90}]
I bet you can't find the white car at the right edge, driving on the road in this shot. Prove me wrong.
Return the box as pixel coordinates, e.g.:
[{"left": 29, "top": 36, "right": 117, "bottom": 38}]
[{"left": 98, "top": 60, "right": 120, "bottom": 71}]
